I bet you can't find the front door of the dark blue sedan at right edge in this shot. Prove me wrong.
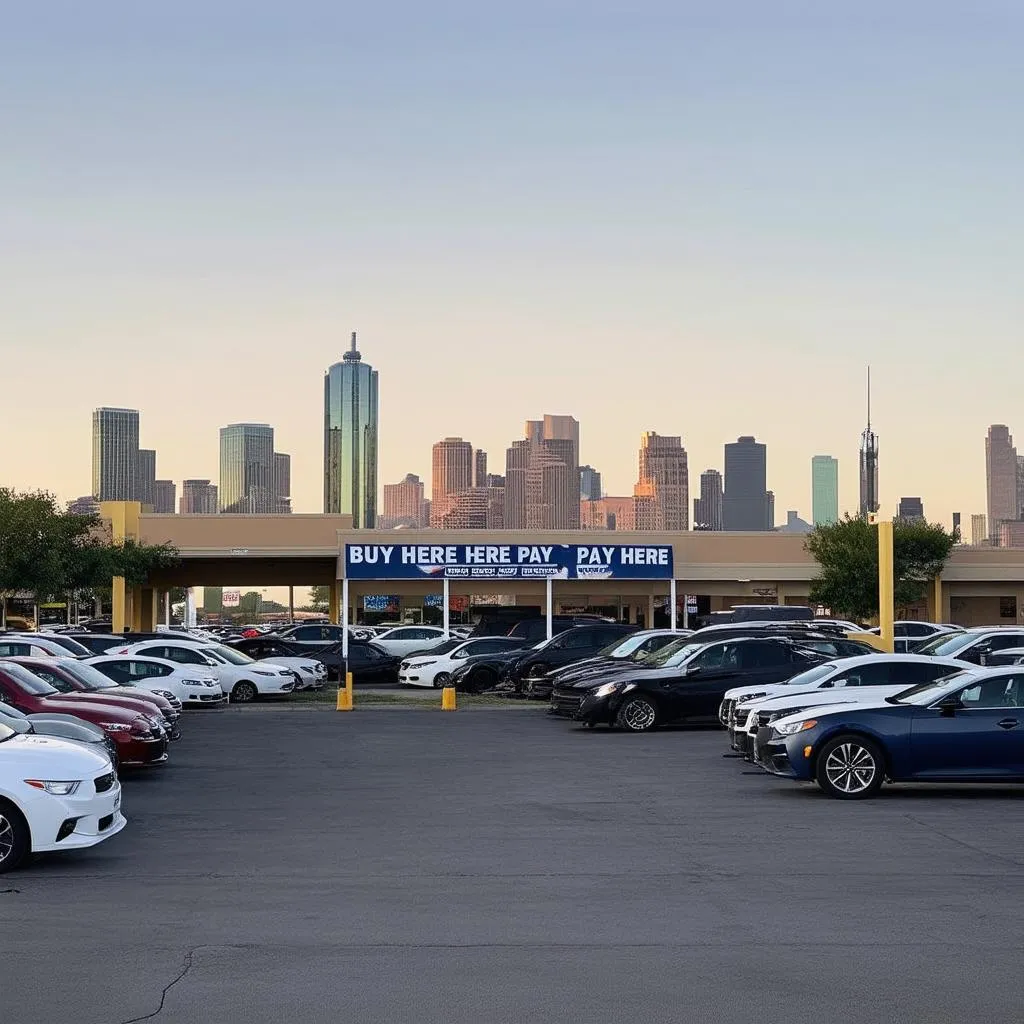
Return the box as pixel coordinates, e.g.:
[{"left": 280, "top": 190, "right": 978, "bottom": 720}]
[{"left": 910, "top": 672, "right": 1024, "bottom": 778}]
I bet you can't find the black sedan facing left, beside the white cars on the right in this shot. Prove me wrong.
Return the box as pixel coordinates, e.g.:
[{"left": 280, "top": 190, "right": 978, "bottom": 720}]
[{"left": 551, "top": 637, "right": 825, "bottom": 732}]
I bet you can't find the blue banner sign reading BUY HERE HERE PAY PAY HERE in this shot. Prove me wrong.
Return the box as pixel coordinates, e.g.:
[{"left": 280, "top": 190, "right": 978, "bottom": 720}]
[{"left": 345, "top": 544, "right": 673, "bottom": 580}]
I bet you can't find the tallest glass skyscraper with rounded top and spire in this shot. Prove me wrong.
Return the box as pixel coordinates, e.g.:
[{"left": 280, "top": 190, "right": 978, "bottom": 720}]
[{"left": 324, "top": 331, "right": 377, "bottom": 529}]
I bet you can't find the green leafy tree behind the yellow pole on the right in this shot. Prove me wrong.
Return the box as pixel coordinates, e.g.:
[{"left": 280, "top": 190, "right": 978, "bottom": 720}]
[{"left": 806, "top": 515, "right": 955, "bottom": 621}]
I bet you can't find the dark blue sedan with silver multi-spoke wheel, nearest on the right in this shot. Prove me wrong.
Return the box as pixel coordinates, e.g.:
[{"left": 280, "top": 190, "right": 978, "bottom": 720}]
[{"left": 764, "top": 668, "right": 1024, "bottom": 800}]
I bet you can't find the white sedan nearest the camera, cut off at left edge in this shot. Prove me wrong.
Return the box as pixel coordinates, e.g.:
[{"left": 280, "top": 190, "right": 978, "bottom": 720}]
[{"left": 0, "top": 725, "right": 126, "bottom": 872}]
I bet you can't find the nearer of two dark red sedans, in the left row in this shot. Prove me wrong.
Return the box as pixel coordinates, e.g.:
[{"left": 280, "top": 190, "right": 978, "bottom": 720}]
[{"left": 0, "top": 662, "right": 167, "bottom": 767}]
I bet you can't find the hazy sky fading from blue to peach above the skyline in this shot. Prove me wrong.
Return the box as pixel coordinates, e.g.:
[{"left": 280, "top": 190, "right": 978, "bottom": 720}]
[{"left": 0, "top": 0, "right": 1024, "bottom": 520}]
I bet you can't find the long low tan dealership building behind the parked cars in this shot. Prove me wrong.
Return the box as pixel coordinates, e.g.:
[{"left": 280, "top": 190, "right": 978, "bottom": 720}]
[{"left": 101, "top": 502, "right": 1024, "bottom": 630}]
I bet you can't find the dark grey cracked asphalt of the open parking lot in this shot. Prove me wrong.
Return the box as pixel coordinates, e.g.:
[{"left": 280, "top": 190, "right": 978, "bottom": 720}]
[{"left": 6, "top": 708, "right": 1024, "bottom": 1024}]
